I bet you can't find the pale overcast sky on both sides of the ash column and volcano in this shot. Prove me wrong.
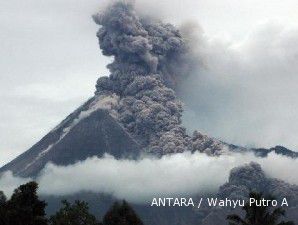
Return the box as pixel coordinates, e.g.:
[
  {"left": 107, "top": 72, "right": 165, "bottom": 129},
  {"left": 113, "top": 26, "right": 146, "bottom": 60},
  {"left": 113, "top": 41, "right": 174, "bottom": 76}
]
[{"left": 0, "top": 0, "right": 298, "bottom": 166}]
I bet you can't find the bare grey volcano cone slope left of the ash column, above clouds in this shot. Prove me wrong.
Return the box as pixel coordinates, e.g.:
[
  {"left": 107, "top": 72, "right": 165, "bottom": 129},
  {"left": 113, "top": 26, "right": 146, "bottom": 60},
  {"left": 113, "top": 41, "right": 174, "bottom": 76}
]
[{"left": 0, "top": 98, "right": 140, "bottom": 177}]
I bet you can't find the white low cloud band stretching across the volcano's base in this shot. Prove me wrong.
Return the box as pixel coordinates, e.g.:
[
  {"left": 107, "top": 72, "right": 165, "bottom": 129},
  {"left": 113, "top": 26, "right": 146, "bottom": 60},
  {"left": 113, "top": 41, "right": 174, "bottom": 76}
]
[{"left": 0, "top": 153, "right": 298, "bottom": 203}]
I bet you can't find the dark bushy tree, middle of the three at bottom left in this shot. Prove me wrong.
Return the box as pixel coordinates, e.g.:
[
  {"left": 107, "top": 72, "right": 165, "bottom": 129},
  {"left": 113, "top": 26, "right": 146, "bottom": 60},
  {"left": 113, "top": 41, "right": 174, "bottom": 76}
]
[{"left": 50, "top": 200, "right": 100, "bottom": 225}]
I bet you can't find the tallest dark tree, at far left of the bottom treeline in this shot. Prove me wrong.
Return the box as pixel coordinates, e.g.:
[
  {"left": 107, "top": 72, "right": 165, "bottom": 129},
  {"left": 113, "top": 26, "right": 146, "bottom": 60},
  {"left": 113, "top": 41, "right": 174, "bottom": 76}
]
[{"left": 6, "top": 182, "right": 47, "bottom": 225}]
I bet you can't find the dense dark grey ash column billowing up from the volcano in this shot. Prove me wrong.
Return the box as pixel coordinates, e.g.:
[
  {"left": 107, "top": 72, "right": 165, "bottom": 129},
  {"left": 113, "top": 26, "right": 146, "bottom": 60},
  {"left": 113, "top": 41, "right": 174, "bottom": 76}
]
[{"left": 93, "top": 1, "right": 219, "bottom": 154}]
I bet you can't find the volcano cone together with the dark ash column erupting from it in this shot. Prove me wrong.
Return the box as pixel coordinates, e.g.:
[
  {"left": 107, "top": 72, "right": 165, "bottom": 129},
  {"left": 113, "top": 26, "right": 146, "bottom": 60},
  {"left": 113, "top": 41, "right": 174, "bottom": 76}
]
[{"left": 0, "top": 1, "right": 227, "bottom": 177}]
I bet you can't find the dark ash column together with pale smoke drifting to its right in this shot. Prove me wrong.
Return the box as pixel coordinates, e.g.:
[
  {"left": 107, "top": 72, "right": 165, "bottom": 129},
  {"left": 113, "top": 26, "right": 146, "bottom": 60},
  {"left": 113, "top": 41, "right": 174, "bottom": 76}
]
[{"left": 94, "top": 1, "right": 298, "bottom": 156}]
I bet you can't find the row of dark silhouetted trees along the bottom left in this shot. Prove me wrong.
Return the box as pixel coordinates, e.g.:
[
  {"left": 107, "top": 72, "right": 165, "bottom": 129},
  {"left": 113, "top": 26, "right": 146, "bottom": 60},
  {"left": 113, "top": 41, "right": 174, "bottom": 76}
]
[{"left": 0, "top": 182, "right": 143, "bottom": 225}]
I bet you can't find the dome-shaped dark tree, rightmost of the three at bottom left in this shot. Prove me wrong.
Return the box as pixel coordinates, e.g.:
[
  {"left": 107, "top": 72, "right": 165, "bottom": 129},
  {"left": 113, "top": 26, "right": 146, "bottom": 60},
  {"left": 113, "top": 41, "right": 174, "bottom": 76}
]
[{"left": 103, "top": 201, "right": 143, "bottom": 225}]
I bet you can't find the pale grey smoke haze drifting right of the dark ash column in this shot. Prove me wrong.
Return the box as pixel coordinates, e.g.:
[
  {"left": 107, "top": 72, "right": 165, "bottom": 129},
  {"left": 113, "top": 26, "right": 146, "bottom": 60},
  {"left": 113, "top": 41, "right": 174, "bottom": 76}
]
[{"left": 180, "top": 22, "right": 298, "bottom": 150}]
